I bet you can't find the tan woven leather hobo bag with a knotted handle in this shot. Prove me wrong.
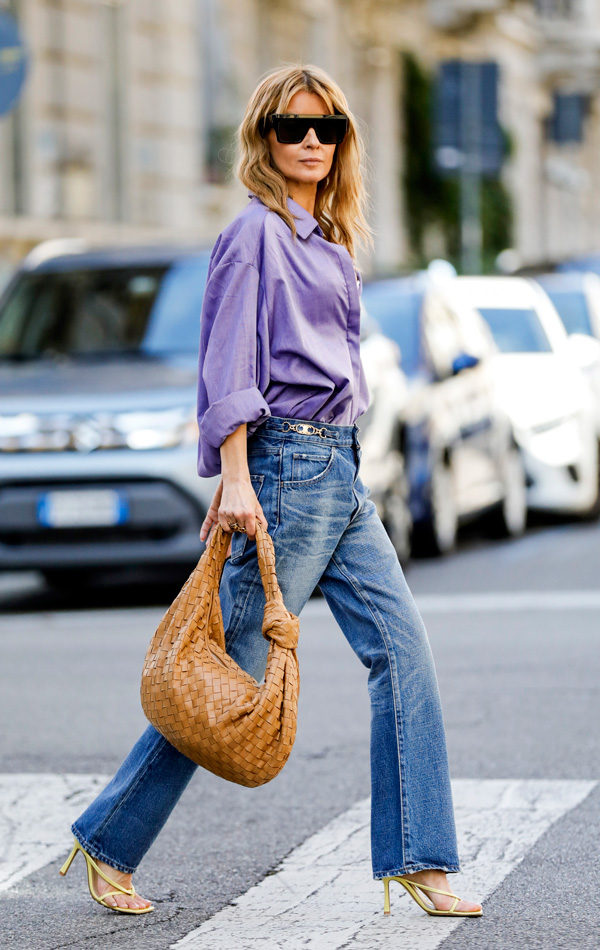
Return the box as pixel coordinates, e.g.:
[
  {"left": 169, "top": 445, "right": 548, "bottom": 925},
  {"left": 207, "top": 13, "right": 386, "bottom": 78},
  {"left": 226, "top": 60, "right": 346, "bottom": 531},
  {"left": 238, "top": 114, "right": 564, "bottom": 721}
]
[{"left": 141, "top": 519, "right": 300, "bottom": 787}]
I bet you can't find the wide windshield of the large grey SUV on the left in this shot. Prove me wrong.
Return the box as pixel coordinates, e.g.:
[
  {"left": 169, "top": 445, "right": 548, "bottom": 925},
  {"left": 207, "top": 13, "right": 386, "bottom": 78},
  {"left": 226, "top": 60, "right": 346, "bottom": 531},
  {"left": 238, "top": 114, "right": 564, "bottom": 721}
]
[{"left": 0, "top": 258, "right": 208, "bottom": 360}]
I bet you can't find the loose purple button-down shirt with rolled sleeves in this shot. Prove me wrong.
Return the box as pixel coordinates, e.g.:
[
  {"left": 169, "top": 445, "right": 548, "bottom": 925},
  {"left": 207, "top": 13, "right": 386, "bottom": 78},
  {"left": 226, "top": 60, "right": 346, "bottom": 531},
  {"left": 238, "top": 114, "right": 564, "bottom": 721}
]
[{"left": 198, "top": 192, "right": 370, "bottom": 477}]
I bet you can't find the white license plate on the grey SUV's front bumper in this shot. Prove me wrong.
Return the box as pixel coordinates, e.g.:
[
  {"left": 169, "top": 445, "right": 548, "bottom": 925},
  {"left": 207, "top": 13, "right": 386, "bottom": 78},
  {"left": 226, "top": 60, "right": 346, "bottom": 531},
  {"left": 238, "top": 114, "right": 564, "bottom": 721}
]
[{"left": 37, "top": 489, "right": 129, "bottom": 528}]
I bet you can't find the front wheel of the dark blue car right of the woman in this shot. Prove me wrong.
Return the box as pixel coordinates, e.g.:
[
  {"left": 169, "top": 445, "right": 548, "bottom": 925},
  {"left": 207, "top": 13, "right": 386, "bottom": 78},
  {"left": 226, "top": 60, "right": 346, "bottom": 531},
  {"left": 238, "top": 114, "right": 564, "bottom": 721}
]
[{"left": 413, "top": 457, "right": 458, "bottom": 557}]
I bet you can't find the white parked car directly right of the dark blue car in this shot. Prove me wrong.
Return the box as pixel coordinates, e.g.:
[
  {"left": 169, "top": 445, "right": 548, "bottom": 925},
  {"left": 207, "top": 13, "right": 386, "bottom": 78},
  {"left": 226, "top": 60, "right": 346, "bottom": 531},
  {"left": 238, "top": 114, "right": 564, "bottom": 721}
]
[{"left": 447, "top": 277, "right": 600, "bottom": 515}]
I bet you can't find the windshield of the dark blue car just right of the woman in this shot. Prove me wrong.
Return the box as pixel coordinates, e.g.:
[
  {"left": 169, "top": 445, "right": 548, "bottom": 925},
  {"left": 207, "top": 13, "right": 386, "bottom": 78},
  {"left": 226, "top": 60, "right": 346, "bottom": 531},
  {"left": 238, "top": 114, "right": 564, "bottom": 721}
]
[{"left": 362, "top": 284, "right": 423, "bottom": 376}]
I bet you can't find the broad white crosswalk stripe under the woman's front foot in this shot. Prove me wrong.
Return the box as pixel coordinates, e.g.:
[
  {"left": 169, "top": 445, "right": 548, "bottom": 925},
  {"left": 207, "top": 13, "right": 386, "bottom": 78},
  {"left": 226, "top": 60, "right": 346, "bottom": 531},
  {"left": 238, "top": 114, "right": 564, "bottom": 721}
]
[{"left": 171, "top": 779, "right": 597, "bottom": 950}]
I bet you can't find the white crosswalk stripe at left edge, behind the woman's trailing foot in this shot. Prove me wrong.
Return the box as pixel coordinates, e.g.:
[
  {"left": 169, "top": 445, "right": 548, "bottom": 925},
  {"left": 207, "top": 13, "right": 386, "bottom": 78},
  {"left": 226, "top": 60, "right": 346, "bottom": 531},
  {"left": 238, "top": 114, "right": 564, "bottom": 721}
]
[{"left": 0, "top": 773, "right": 108, "bottom": 891}]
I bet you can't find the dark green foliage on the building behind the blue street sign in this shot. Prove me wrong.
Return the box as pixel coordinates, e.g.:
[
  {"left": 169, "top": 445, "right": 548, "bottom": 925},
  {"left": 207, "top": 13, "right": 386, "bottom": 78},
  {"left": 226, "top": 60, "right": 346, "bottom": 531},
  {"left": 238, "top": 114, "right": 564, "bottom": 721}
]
[{"left": 402, "top": 53, "right": 514, "bottom": 271}]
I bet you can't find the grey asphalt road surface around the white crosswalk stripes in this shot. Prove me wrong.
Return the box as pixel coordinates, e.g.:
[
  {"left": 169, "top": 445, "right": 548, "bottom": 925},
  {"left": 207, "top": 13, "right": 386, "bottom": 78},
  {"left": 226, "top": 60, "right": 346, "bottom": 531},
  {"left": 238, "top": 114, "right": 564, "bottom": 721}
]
[{"left": 0, "top": 524, "right": 600, "bottom": 950}]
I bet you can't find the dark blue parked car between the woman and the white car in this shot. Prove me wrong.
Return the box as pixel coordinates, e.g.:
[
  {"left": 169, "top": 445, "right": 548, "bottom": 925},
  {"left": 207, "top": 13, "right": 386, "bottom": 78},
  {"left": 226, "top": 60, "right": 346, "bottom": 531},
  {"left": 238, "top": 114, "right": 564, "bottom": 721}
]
[{"left": 363, "top": 275, "right": 527, "bottom": 553}]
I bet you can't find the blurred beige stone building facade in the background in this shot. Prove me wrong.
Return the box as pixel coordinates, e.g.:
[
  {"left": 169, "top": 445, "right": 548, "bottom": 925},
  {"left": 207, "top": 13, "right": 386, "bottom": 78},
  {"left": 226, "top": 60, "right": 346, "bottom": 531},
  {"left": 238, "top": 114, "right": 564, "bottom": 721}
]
[{"left": 0, "top": 0, "right": 600, "bottom": 273}]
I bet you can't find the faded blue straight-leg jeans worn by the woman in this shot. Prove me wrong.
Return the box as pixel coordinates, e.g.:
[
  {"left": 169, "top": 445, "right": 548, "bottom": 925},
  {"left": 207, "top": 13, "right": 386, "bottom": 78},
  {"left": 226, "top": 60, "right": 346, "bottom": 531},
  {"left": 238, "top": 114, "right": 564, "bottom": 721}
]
[{"left": 72, "top": 416, "right": 460, "bottom": 878}]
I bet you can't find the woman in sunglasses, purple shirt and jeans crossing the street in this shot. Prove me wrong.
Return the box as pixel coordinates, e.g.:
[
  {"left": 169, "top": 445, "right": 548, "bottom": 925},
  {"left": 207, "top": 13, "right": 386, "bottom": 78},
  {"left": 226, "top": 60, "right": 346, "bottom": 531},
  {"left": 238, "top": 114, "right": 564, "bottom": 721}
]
[{"left": 61, "top": 65, "right": 481, "bottom": 916}]
